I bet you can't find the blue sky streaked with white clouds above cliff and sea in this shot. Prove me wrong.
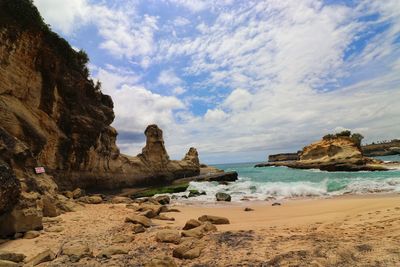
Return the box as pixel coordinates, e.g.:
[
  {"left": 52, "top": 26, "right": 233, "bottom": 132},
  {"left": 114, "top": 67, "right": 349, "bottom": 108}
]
[{"left": 34, "top": 0, "right": 400, "bottom": 163}]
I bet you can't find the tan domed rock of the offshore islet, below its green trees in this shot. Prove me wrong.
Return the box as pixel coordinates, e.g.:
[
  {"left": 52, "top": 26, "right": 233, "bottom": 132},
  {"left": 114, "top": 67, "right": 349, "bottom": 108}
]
[{"left": 256, "top": 136, "right": 386, "bottom": 171}]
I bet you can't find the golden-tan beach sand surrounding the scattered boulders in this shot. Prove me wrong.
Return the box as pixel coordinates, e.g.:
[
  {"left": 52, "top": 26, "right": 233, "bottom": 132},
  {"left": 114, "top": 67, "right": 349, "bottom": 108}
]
[{"left": 0, "top": 194, "right": 400, "bottom": 266}]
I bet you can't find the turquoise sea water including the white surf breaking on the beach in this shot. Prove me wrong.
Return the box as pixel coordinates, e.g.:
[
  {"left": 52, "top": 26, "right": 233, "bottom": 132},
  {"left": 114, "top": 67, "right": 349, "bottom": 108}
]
[{"left": 186, "top": 155, "right": 400, "bottom": 201}]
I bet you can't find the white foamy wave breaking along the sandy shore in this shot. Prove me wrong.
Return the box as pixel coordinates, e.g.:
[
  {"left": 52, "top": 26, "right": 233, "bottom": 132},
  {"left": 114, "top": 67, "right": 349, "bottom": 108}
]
[{"left": 173, "top": 177, "right": 400, "bottom": 201}]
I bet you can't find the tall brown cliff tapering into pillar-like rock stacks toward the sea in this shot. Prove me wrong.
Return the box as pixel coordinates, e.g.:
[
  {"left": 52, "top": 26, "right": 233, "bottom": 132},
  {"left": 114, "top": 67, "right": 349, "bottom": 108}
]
[{"left": 0, "top": 0, "right": 200, "bottom": 238}]
